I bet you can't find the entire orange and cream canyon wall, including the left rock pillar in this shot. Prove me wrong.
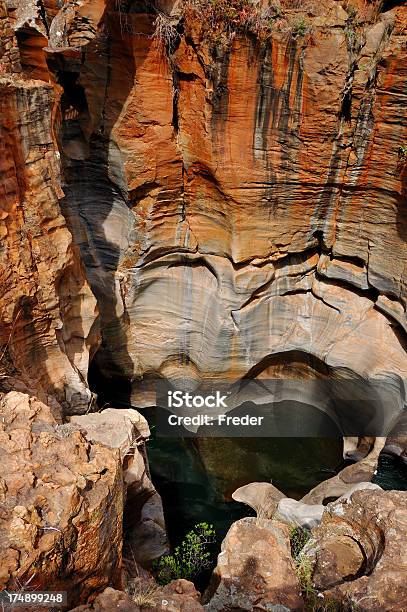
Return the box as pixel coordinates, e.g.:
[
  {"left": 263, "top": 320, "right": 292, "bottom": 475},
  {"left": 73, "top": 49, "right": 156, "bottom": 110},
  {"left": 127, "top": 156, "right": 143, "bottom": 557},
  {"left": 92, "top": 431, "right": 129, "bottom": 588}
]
[{"left": 1, "top": 0, "right": 407, "bottom": 412}]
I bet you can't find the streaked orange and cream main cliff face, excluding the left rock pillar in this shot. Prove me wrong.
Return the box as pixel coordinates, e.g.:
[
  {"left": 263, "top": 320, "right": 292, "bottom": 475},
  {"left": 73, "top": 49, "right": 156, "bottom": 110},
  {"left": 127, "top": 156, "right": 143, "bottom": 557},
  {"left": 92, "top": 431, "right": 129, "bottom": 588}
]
[{"left": 16, "top": 0, "right": 407, "bottom": 412}]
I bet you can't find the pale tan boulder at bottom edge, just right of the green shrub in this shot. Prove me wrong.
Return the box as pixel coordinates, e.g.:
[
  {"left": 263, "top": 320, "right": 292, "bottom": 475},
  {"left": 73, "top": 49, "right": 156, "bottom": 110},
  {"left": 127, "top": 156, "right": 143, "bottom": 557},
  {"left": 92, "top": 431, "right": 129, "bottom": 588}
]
[{"left": 204, "top": 518, "right": 303, "bottom": 612}]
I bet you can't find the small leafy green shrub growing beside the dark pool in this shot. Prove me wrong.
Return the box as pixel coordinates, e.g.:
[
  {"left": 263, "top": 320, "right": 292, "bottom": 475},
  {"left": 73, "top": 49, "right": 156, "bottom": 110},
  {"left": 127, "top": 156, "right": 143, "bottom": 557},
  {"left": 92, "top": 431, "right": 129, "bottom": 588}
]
[{"left": 155, "top": 523, "right": 215, "bottom": 584}]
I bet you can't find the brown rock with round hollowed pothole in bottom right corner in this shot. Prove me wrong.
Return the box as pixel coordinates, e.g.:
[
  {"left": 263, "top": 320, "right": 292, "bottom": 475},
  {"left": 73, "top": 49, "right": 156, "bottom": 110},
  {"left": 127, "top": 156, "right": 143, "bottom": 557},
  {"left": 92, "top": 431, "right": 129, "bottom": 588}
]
[{"left": 306, "top": 491, "right": 407, "bottom": 612}]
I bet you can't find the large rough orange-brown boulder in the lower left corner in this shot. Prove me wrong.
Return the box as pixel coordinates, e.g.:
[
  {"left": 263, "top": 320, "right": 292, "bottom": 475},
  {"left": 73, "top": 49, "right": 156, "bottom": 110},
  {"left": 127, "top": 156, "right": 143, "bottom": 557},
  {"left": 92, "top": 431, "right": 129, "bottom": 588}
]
[{"left": 0, "top": 392, "right": 123, "bottom": 603}]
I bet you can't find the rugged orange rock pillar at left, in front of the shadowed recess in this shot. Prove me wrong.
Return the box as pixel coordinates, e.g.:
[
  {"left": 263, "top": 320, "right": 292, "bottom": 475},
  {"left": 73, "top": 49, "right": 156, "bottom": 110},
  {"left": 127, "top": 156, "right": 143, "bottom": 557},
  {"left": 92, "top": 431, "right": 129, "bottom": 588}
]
[{"left": 0, "top": 75, "right": 99, "bottom": 411}]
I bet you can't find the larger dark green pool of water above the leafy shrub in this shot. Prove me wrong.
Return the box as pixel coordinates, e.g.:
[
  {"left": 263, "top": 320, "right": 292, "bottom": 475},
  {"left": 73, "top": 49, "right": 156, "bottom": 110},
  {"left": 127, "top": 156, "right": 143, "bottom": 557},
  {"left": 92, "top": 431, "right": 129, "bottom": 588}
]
[{"left": 143, "top": 430, "right": 343, "bottom": 544}]
